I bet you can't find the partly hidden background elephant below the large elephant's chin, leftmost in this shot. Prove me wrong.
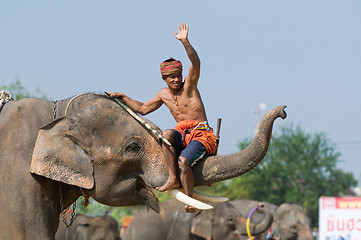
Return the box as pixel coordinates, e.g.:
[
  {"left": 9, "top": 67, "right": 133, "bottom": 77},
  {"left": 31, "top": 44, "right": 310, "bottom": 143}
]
[{"left": 55, "top": 214, "right": 120, "bottom": 240}]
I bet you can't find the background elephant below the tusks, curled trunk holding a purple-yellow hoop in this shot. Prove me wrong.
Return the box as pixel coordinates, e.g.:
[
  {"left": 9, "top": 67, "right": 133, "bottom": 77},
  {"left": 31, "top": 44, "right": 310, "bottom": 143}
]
[{"left": 122, "top": 199, "right": 273, "bottom": 240}]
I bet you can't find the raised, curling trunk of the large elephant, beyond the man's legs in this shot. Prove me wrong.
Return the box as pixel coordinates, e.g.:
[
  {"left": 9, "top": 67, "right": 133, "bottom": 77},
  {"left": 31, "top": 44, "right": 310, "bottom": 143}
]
[{"left": 193, "top": 106, "right": 287, "bottom": 186}]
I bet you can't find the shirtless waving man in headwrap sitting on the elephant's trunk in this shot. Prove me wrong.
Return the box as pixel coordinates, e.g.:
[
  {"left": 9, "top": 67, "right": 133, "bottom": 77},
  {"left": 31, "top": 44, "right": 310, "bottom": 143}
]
[{"left": 109, "top": 23, "right": 217, "bottom": 212}]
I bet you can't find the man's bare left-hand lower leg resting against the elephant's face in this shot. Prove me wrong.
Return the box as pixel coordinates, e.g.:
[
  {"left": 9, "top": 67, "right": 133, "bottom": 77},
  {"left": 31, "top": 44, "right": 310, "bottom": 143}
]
[{"left": 156, "top": 129, "right": 179, "bottom": 192}]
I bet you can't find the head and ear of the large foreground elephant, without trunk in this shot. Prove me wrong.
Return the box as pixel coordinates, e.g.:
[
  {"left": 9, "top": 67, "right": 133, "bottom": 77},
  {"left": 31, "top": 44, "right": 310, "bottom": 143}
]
[{"left": 30, "top": 94, "right": 164, "bottom": 211}]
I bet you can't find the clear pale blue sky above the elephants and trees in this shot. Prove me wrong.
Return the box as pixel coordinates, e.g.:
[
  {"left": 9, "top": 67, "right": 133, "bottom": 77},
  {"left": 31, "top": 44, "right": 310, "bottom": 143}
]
[{"left": 0, "top": 0, "right": 361, "bottom": 182}]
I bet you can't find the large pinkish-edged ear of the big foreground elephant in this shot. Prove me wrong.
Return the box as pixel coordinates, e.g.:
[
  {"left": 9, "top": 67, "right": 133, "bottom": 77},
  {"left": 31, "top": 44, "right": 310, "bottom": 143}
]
[{"left": 30, "top": 117, "right": 94, "bottom": 189}]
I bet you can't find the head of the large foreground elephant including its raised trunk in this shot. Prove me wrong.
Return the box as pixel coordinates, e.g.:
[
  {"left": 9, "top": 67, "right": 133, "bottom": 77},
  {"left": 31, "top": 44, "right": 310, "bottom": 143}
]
[{"left": 30, "top": 94, "right": 286, "bottom": 211}]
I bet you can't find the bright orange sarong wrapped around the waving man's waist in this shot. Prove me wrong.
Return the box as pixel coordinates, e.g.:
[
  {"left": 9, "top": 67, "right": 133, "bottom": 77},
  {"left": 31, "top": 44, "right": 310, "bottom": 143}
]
[{"left": 174, "top": 120, "right": 217, "bottom": 155}]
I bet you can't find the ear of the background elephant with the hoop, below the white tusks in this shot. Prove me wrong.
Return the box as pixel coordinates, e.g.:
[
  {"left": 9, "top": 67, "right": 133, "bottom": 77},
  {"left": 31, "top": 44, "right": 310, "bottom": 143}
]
[{"left": 191, "top": 209, "right": 214, "bottom": 240}]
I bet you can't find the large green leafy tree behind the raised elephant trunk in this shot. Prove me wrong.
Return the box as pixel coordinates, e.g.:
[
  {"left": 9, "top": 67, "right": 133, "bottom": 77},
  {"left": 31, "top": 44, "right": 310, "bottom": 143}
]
[{"left": 233, "top": 125, "right": 357, "bottom": 224}]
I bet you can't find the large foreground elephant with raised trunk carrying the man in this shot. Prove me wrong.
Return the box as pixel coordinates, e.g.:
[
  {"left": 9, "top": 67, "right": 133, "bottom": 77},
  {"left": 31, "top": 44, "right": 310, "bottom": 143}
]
[{"left": 0, "top": 93, "right": 287, "bottom": 239}]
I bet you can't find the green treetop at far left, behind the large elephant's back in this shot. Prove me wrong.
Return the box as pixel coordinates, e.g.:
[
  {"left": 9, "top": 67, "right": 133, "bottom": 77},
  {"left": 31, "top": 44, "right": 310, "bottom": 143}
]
[{"left": 0, "top": 76, "right": 47, "bottom": 100}]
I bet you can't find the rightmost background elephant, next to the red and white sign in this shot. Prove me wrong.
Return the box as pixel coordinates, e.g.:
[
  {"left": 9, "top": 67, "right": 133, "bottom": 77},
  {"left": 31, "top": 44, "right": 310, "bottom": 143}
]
[{"left": 231, "top": 199, "right": 314, "bottom": 240}]
